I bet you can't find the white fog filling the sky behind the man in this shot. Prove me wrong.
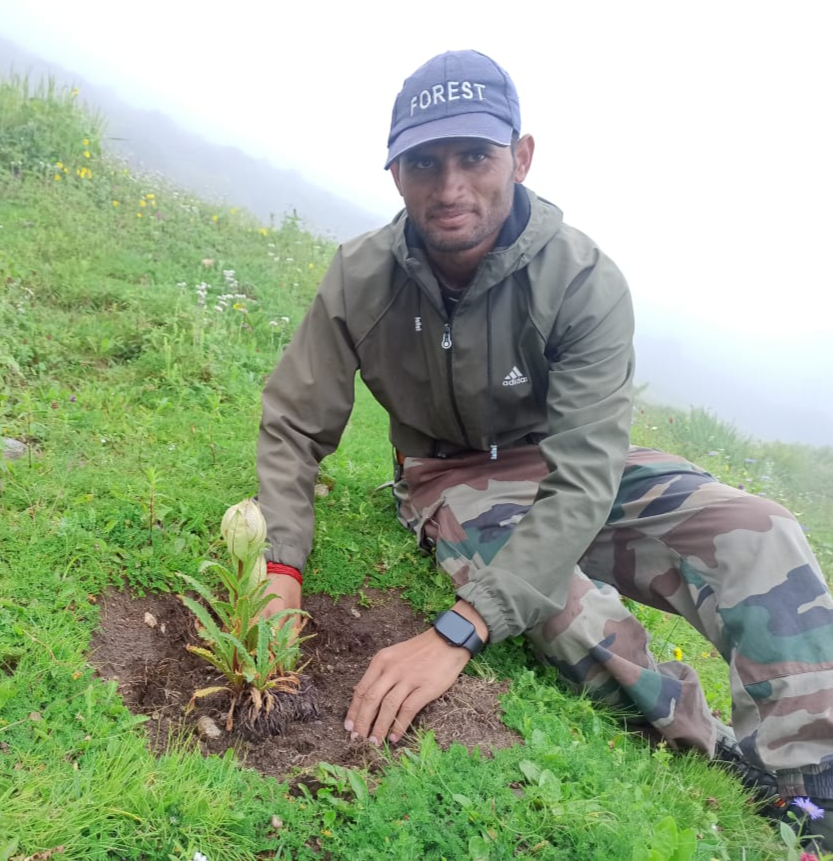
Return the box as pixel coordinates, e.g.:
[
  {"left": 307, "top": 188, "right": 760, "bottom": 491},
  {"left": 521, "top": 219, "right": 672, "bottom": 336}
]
[{"left": 0, "top": 0, "right": 833, "bottom": 444}]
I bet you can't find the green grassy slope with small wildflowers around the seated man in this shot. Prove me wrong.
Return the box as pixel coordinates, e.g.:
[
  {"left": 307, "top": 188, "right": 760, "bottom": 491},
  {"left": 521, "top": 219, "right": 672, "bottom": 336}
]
[{"left": 0, "top": 75, "right": 833, "bottom": 861}]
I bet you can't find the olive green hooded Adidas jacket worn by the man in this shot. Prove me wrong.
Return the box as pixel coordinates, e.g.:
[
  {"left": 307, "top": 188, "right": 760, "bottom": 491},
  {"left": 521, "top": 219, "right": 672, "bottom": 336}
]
[{"left": 258, "top": 191, "right": 634, "bottom": 642}]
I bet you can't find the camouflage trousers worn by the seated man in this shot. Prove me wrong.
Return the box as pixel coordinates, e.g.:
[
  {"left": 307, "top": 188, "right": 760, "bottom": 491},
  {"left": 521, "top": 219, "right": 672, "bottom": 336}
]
[{"left": 394, "top": 446, "right": 833, "bottom": 798}]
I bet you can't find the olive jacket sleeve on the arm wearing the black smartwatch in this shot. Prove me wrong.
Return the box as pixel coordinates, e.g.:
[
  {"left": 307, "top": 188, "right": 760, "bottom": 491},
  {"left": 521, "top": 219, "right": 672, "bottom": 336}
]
[{"left": 457, "top": 255, "right": 634, "bottom": 642}]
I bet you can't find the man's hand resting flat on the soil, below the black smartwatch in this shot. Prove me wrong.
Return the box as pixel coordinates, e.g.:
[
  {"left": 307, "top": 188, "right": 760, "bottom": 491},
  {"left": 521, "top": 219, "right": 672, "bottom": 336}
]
[{"left": 344, "top": 601, "right": 489, "bottom": 745}]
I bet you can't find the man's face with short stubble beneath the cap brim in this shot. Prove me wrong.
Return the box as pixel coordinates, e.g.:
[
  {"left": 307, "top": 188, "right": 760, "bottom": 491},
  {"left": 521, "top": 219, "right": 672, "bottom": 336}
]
[{"left": 391, "top": 136, "right": 532, "bottom": 254}]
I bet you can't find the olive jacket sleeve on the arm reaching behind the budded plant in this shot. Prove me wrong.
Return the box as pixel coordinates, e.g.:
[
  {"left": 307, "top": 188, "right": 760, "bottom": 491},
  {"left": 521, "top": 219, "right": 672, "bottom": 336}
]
[{"left": 257, "top": 251, "right": 358, "bottom": 569}]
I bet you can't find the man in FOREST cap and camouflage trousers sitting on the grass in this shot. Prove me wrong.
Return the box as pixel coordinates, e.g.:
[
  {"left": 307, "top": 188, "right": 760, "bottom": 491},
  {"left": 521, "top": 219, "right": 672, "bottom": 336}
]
[{"left": 258, "top": 51, "right": 833, "bottom": 848}]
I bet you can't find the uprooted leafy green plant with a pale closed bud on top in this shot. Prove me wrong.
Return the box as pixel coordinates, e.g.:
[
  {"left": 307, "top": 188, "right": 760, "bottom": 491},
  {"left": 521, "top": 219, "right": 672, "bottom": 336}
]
[{"left": 179, "top": 499, "right": 317, "bottom": 732}]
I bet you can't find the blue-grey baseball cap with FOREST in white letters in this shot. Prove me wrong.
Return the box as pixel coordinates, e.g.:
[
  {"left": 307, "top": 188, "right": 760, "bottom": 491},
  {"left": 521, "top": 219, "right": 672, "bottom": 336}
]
[{"left": 385, "top": 51, "right": 521, "bottom": 169}]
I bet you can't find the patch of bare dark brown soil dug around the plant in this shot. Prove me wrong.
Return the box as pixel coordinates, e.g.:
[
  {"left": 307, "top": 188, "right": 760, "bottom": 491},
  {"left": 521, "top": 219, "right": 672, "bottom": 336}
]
[{"left": 90, "top": 589, "right": 519, "bottom": 778}]
